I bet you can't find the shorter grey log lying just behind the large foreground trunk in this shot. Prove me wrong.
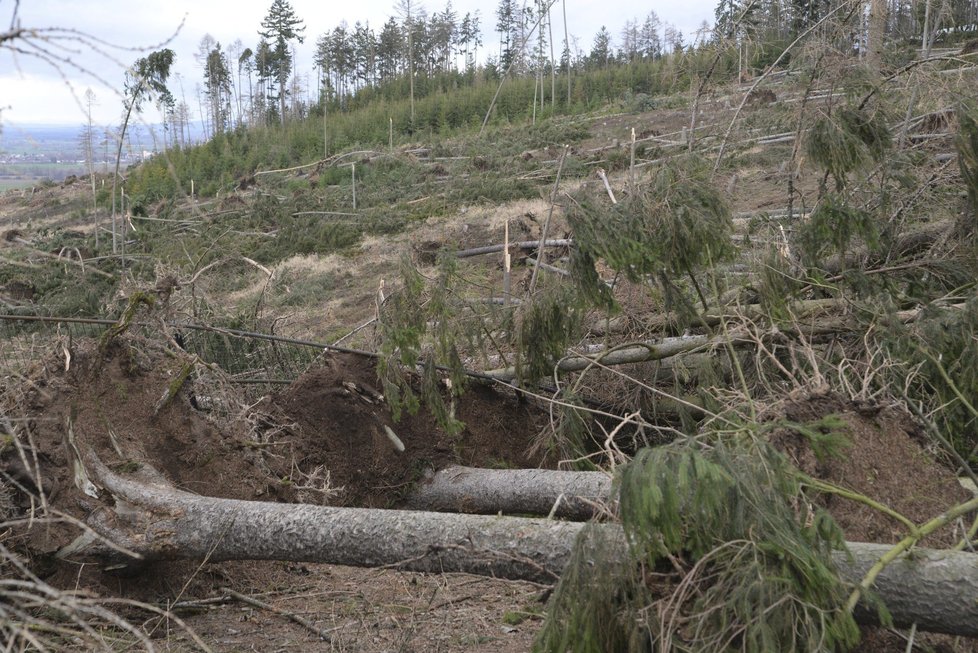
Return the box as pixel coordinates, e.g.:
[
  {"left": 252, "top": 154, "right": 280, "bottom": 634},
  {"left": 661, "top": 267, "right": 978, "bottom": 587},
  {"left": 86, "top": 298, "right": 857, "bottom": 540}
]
[{"left": 405, "top": 466, "right": 616, "bottom": 520}]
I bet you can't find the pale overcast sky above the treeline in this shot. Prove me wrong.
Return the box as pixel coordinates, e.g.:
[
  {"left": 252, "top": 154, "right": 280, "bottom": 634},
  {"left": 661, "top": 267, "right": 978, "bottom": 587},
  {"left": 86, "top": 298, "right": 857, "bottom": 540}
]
[{"left": 0, "top": 0, "right": 716, "bottom": 128}]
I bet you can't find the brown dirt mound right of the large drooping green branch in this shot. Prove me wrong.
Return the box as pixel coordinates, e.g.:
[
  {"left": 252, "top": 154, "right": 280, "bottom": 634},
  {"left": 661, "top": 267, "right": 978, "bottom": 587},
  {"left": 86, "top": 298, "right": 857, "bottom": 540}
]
[{"left": 773, "top": 395, "right": 972, "bottom": 548}]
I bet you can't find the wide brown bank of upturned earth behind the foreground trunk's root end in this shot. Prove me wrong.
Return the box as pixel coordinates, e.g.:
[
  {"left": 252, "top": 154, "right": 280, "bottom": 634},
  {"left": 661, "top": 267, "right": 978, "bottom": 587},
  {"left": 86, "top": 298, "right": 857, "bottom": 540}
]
[{"left": 0, "top": 335, "right": 542, "bottom": 509}]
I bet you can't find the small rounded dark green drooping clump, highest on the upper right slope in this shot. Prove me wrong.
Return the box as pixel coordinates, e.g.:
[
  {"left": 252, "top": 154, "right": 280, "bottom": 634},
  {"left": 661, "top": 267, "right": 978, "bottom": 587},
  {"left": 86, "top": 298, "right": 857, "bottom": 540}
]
[{"left": 805, "top": 107, "right": 892, "bottom": 189}]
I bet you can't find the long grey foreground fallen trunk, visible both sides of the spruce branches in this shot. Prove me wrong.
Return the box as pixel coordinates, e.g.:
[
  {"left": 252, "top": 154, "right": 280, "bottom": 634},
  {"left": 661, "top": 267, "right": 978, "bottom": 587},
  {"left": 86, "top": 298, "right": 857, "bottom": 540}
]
[{"left": 70, "top": 460, "right": 978, "bottom": 636}]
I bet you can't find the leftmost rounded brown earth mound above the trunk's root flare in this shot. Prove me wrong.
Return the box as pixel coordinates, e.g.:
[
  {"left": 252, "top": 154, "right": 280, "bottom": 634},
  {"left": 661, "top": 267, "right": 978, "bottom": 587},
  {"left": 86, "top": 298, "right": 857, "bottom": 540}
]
[{"left": 0, "top": 336, "right": 278, "bottom": 524}]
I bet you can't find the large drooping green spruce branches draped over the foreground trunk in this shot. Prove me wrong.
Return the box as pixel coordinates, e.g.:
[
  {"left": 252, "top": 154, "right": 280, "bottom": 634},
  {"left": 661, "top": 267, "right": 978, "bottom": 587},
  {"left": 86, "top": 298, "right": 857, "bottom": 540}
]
[{"left": 536, "top": 429, "right": 859, "bottom": 652}]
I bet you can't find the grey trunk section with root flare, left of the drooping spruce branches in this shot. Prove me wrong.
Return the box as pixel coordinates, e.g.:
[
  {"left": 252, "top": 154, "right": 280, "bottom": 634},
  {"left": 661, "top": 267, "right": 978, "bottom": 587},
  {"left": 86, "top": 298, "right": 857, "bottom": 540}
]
[{"left": 76, "top": 460, "right": 584, "bottom": 583}]
